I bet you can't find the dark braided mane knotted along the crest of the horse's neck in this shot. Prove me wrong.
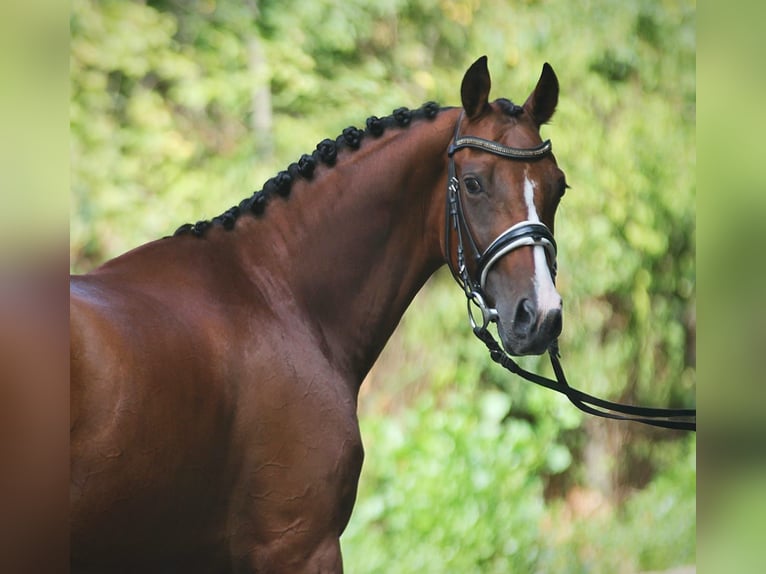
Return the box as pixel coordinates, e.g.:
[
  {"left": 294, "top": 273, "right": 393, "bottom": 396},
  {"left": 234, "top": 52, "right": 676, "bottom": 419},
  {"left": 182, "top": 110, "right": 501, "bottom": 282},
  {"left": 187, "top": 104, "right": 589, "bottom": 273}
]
[{"left": 173, "top": 102, "right": 440, "bottom": 237}]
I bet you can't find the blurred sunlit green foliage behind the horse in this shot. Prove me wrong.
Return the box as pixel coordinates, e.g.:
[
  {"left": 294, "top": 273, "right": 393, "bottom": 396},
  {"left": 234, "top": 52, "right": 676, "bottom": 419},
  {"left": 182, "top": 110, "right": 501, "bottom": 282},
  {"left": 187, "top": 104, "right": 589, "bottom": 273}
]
[{"left": 70, "top": 0, "right": 696, "bottom": 573}]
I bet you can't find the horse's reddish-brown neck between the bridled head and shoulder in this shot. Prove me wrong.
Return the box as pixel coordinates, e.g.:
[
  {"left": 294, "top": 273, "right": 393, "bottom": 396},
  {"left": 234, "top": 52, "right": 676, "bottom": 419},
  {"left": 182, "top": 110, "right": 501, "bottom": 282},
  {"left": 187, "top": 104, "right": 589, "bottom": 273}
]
[{"left": 242, "top": 110, "right": 456, "bottom": 382}]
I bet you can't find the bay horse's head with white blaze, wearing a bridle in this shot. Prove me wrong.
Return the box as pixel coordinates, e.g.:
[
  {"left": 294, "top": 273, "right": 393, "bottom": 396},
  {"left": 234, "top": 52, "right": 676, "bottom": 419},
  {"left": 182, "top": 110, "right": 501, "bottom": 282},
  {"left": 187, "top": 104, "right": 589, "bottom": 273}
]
[{"left": 447, "top": 57, "right": 567, "bottom": 355}]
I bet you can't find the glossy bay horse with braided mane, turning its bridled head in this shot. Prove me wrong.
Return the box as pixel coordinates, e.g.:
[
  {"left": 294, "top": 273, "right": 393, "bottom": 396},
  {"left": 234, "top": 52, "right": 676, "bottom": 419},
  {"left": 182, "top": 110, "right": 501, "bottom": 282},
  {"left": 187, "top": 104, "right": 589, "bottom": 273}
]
[{"left": 70, "top": 57, "right": 566, "bottom": 573}]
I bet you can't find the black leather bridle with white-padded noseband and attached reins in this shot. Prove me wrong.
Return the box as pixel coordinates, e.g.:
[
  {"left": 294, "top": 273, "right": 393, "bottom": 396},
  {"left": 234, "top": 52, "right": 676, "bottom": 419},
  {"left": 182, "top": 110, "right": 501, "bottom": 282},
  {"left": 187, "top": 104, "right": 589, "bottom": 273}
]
[{"left": 444, "top": 114, "right": 697, "bottom": 431}]
